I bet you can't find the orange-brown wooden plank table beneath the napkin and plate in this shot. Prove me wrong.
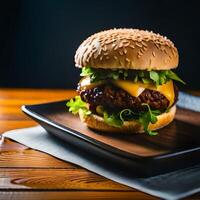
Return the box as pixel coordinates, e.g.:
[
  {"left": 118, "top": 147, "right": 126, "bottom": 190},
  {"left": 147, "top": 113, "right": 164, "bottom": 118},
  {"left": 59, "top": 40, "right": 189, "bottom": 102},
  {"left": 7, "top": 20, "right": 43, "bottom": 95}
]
[{"left": 0, "top": 89, "right": 200, "bottom": 200}]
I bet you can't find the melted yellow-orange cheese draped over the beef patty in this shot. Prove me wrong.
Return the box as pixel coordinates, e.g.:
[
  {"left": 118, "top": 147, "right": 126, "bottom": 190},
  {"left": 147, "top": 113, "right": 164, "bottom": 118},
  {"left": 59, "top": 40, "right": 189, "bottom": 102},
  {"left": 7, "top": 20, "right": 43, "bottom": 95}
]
[{"left": 79, "top": 77, "right": 175, "bottom": 107}]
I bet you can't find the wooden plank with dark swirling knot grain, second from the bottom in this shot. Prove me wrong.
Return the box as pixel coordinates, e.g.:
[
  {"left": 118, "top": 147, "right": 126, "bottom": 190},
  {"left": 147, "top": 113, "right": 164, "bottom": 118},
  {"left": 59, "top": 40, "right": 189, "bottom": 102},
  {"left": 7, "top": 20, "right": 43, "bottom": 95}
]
[{"left": 0, "top": 168, "right": 133, "bottom": 191}]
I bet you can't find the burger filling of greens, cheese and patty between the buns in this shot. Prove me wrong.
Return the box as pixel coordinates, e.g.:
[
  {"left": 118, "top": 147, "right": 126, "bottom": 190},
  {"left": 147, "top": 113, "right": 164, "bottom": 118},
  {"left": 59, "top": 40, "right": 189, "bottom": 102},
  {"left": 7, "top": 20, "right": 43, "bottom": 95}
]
[{"left": 67, "top": 67, "right": 184, "bottom": 135}]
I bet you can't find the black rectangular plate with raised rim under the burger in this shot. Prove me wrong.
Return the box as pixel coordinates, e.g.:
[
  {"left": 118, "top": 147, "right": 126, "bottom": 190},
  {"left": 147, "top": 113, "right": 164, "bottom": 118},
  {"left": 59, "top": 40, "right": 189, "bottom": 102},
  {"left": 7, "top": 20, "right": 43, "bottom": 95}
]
[{"left": 22, "top": 101, "right": 200, "bottom": 176}]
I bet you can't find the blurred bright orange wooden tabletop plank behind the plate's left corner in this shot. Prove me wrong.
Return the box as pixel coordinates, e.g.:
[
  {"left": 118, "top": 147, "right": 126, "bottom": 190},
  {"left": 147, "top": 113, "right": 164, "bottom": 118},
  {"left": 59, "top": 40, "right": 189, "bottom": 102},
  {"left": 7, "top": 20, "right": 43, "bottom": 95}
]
[{"left": 0, "top": 89, "right": 76, "bottom": 121}]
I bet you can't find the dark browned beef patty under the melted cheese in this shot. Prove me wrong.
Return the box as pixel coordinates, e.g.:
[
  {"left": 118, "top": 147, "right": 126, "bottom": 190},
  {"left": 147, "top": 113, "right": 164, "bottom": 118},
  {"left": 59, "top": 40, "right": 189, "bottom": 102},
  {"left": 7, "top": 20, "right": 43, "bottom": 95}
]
[{"left": 79, "top": 85, "right": 178, "bottom": 112}]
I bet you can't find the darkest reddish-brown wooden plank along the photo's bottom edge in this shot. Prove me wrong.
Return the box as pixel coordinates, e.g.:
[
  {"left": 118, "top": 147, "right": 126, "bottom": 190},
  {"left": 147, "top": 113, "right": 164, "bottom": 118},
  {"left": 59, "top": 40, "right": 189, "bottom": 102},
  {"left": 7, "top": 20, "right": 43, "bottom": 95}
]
[{"left": 0, "top": 191, "right": 156, "bottom": 200}]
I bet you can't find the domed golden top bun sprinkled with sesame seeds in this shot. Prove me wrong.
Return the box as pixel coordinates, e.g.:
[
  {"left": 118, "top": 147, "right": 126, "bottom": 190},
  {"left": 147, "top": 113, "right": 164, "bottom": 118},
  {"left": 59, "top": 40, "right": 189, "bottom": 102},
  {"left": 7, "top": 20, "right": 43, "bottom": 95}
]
[{"left": 75, "top": 29, "right": 179, "bottom": 70}]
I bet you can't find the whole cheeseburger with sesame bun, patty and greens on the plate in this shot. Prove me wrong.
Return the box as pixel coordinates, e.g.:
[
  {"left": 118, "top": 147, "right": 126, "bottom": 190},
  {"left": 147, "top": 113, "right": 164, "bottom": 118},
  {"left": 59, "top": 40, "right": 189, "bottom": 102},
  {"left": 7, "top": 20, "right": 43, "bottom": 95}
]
[{"left": 67, "top": 29, "right": 184, "bottom": 135}]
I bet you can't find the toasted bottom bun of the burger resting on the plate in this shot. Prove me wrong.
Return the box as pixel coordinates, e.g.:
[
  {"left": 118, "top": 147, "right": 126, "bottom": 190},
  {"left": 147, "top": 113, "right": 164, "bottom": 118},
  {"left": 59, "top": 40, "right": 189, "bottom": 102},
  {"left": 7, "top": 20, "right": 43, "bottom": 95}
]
[{"left": 79, "top": 105, "right": 176, "bottom": 133}]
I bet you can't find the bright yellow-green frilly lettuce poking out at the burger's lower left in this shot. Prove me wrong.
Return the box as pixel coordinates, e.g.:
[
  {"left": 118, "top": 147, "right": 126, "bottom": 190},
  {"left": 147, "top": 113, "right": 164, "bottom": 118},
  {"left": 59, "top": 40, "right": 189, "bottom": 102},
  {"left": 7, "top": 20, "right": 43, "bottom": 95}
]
[{"left": 66, "top": 96, "right": 91, "bottom": 115}]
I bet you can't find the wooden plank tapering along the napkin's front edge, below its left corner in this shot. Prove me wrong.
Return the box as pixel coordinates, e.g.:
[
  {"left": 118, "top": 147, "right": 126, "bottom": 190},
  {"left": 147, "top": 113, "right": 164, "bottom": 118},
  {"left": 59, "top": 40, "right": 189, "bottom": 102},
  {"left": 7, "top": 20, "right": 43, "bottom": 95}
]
[{"left": 0, "top": 139, "right": 76, "bottom": 170}]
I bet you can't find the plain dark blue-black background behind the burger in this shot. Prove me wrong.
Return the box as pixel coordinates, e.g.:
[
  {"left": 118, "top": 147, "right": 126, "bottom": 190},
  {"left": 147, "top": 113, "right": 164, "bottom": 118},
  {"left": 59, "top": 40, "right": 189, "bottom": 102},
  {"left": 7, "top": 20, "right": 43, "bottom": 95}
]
[{"left": 0, "top": 0, "right": 200, "bottom": 89}]
